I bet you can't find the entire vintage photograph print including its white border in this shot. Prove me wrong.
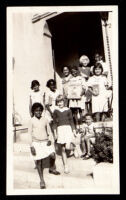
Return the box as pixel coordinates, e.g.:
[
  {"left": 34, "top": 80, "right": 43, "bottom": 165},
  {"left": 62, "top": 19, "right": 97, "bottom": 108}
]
[{"left": 6, "top": 5, "right": 120, "bottom": 195}]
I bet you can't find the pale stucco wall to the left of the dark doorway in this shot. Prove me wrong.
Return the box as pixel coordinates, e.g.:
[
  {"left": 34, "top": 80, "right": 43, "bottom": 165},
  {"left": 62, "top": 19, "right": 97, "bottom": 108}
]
[{"left": 12, "top": 13, "right": 54, "bottom": 123}]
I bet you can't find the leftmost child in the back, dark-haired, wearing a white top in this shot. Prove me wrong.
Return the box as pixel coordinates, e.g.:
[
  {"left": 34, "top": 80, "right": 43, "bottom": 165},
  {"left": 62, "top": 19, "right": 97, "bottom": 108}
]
[{"left": 29, "top": 80, "right": 43, "bottom": 117}]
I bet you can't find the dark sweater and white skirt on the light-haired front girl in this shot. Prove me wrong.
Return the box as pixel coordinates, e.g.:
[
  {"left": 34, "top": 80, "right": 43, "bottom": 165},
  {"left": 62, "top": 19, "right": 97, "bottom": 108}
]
[{"left": 53, "top": 107, "right": 75, "bottom": 144}]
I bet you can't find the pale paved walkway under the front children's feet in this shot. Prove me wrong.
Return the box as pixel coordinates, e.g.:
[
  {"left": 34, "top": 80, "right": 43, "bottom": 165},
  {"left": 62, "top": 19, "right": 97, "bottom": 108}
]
[{"left": 14, "top": 152, "right": 95, "bottom": 189}]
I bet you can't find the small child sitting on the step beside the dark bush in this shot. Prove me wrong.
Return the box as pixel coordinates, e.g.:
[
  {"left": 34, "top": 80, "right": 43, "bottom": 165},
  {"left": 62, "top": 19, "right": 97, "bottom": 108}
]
[{"left": 81, "top": 114, "right": 95, "bottom": 159}]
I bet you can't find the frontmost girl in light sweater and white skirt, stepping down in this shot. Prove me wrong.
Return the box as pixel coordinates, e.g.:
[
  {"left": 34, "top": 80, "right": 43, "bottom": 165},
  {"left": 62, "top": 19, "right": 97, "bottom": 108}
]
[{"left": 30, "top": 103, "right": 60, "bottom": 189}]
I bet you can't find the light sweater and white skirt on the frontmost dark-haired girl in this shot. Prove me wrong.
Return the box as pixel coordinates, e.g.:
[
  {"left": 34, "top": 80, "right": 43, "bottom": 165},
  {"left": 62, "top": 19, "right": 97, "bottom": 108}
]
[{"left": 29, "top": 117, "right": 55, "bottom": 160}]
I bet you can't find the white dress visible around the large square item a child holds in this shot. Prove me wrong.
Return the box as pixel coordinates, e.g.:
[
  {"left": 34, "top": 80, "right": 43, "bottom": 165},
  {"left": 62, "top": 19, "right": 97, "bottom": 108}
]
[{"left": 68, "top": 76, "right": 87, "bottom": 109}]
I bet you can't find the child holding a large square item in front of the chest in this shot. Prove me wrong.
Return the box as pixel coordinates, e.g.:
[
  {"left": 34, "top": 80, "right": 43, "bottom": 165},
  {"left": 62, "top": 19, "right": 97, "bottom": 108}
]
[{"left": 68, "top": 66, "right": 86, "bottom": 129}]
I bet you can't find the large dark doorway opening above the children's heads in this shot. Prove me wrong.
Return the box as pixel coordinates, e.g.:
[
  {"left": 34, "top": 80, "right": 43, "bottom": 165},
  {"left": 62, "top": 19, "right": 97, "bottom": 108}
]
[{"left": 47, "top": 12, "right": 104, "bottom": 76}]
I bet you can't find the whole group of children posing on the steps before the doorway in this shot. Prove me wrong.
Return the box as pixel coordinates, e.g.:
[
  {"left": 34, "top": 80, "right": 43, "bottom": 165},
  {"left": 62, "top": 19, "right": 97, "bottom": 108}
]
[{"left": 29, "top": 52, "right": 112, "bottom": 189}]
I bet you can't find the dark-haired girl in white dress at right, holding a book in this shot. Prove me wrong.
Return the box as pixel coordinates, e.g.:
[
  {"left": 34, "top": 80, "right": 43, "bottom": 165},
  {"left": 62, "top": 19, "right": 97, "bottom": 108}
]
[{"left": 88, "top": 63, "right": 111, "bottom": 121}]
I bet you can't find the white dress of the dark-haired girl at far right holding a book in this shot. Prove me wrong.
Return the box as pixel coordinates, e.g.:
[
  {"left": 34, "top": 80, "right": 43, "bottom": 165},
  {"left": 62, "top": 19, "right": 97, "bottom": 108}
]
[{"left": 87, "top": 75, "right": 110, "bottom": 113}]
